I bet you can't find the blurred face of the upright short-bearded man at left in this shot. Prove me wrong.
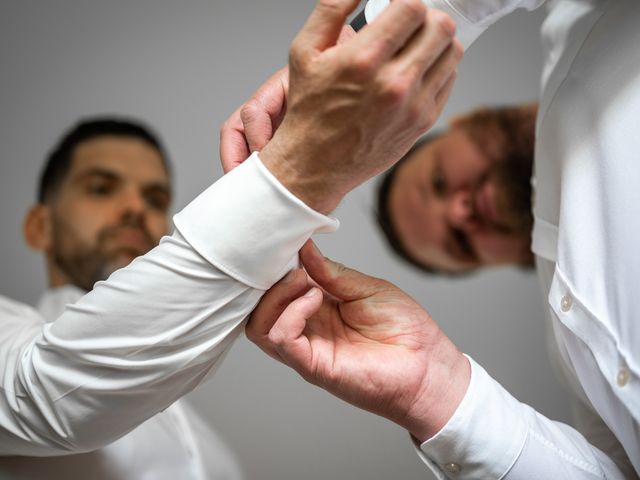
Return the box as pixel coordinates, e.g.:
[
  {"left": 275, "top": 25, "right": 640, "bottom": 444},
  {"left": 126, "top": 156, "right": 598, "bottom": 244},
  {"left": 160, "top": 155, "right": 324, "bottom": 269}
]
[{"left": 47, "top": 136, "right": 170, "bottom": 290}]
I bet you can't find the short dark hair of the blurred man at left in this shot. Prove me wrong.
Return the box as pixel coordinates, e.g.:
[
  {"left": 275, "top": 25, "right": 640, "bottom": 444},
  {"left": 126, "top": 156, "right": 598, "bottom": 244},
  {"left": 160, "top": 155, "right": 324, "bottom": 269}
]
[{"left": 38, "top": 117, "right": 171, "bottom": 203}]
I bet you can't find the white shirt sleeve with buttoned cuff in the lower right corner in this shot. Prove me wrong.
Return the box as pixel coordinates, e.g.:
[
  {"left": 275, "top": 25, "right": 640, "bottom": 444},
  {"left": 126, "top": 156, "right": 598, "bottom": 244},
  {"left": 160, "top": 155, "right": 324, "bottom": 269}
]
[{"left": 419, "top": 359, "right": 628, "bottom": 480}]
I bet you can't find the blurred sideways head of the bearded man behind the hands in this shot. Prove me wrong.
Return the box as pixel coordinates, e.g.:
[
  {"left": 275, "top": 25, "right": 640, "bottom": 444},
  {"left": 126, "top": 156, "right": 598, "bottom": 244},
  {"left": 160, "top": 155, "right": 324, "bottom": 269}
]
[{"left": 377, "top": 104, "right": 537, "bottom": 274}]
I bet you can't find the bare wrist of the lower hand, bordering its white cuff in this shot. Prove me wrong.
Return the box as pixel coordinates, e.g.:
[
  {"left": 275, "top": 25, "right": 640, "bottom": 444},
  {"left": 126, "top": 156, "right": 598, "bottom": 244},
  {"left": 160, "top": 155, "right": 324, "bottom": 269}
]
[{"left": 405, "top": 337, "right": 471, "bottom": 442}]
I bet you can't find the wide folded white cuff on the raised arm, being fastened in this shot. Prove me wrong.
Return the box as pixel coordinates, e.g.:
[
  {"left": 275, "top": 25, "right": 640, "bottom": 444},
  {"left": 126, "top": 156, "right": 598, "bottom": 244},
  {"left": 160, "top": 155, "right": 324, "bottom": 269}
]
[{"left": 173, "top": 153, "right": 339, "bottom": 290}]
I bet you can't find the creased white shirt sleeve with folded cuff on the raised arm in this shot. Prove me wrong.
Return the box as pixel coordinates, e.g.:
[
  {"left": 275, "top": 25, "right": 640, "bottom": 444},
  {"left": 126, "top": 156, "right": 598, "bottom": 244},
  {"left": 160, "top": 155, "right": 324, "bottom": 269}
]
[{"left": 0, "top": 154, "right": 337, "bottom": 456}]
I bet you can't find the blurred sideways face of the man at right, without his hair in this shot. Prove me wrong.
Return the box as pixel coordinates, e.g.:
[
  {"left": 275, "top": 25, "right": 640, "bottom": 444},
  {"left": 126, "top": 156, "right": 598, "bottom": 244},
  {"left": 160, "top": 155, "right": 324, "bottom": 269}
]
[{"left": 389, "top": 128, "right": 531, "bottom": 272}]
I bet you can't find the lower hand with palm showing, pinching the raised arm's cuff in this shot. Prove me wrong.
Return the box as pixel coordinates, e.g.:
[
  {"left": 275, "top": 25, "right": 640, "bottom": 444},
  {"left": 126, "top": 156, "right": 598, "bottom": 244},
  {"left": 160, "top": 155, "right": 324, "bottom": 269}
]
[{"left": 246, "top": 242, "right": 470, "bottom": 441}]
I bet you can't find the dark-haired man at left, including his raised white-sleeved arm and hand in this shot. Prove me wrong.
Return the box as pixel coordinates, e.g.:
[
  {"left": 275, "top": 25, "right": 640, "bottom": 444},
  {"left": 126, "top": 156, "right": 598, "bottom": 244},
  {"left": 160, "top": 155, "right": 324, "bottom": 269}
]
[{"left": 0, "top": 0, "right": 461, "bottom": 480}]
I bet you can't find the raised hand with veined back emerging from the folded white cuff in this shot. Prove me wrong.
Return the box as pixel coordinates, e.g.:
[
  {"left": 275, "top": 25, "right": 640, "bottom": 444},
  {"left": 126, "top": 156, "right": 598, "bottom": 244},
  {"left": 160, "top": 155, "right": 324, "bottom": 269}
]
[{"left": 260, "top": 0, "right": 462, "bottom": 213}]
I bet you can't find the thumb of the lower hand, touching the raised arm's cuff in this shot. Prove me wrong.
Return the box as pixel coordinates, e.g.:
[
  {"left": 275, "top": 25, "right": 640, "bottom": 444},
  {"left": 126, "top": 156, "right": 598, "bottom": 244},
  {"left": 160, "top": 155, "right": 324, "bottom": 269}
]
[{"left": 300, "top": 240, "right": 388, "bottom": 301}]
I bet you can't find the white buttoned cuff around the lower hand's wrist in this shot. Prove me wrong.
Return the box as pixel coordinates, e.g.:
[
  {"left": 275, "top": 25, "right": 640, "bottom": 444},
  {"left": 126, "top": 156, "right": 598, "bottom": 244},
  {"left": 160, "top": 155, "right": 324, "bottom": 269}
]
[{"left": 414, "top": 356, "right": 527, "bottom": 480}]
